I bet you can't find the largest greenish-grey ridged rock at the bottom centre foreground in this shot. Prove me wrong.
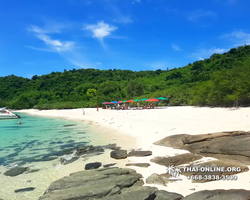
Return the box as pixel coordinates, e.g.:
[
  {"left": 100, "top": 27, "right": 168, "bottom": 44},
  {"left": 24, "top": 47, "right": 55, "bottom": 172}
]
[{"left": 40, "top": 168, "right": 183, "bottom": 200}]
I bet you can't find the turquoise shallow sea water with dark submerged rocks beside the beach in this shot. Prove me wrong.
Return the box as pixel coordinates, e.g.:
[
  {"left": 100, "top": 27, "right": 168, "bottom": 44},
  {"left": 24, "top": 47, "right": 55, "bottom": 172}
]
[{"left": 0, "top": 113, "right": 92, "bottom": 165}]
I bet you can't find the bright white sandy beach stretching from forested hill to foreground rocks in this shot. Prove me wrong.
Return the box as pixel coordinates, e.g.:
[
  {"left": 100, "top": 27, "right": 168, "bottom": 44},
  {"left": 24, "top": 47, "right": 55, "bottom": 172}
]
[{"left": 18, "top": 106, "right": 250, "bottom": 196}]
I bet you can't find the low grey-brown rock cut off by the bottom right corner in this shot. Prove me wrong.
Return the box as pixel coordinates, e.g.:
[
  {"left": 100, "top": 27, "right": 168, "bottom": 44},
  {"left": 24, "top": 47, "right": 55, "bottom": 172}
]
[{"left": 184, "top": 190, "right": 250, "bottom": 200}]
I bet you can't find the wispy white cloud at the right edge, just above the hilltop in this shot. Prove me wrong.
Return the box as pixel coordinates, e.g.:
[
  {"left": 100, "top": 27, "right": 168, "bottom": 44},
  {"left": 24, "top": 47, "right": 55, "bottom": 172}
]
[{"left": 221, "top": 31, "right": 250, "bottom": 47}]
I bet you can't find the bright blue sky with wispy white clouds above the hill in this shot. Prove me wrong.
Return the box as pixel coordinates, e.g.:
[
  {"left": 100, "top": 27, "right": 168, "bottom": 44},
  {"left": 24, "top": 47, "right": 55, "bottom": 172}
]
[{"left": 0, "top": 0, "right": 250, "bottom": 78}]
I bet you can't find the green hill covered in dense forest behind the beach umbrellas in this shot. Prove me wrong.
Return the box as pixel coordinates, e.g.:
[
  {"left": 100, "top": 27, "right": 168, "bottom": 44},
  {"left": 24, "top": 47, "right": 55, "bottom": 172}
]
[{"left": 0, "top": 45, "right": 250, "bottom": 109}]
